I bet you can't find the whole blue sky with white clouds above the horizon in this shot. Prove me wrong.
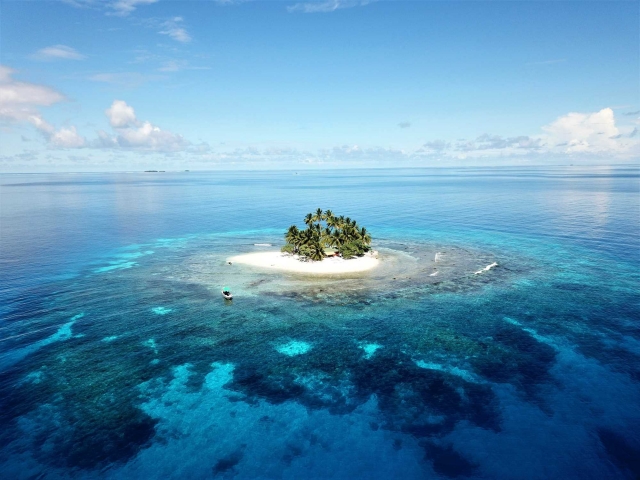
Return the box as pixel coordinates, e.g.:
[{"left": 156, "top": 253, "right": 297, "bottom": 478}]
[{"left": 0, "top": 0, "right": 640, "bottom": 172}]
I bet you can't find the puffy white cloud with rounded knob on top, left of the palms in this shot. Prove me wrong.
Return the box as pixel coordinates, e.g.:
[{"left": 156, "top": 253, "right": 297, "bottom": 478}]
[{"left": 95, "top": 100, "right": 189, "bottom": 152}]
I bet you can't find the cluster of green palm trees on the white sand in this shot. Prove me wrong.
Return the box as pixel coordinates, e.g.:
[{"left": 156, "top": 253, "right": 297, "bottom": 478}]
[{"left": 282, "top": 208, "right": 371, "bottom": 260}]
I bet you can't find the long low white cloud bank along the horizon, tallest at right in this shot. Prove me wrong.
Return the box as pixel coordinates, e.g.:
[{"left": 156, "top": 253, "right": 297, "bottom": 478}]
[{"left": 188, "top": 109, "right": 640, "bottom": 166}]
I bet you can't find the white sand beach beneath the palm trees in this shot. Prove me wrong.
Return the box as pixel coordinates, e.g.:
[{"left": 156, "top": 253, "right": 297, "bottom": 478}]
[{"left": 227, "top": 252, "right": 380, "bottom": 275}]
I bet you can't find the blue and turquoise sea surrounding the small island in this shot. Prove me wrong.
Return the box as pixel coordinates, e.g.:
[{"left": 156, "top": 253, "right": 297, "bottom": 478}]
[{"left": 0, "top": 166, "right": 640, "bottom": 479}]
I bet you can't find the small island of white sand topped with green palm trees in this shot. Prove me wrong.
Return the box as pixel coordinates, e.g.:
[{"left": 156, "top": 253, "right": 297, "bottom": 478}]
[{"left": 227, "top": 208, "right": 379, "bottom": 274}]
